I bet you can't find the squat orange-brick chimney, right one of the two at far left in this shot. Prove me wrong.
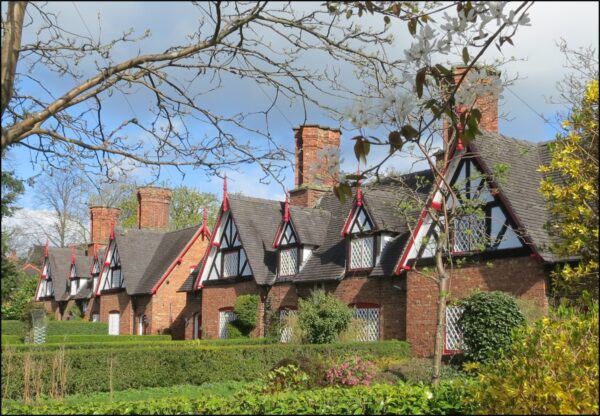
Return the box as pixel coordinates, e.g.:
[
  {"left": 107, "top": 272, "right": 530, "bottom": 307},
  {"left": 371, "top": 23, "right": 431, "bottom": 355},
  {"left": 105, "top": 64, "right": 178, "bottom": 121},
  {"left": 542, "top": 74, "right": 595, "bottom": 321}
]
[{"left": 137, "top": 186, "right": 172, "bottom": 231}]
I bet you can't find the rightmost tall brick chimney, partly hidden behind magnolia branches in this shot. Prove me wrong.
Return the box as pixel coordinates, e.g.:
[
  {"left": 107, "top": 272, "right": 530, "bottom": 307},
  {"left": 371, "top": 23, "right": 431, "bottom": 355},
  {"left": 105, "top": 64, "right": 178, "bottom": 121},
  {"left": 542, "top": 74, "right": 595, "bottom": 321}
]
[{"left": 444, "top": 66, "right": 500, "bottom": 143}]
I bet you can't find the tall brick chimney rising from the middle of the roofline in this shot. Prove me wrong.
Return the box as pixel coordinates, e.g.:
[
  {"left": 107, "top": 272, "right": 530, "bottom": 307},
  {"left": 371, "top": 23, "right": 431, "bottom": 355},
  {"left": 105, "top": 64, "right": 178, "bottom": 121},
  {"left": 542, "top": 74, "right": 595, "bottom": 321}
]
[{"left": 290, "top": 124, "right": 341, "bottom": 207}]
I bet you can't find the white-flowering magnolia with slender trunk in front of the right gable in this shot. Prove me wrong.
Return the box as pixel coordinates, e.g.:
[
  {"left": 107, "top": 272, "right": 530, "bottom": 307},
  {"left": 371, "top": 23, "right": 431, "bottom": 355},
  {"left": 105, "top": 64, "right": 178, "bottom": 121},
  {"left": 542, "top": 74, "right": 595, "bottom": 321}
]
[{"left": 334, "top": 2, "right": 532, "bottom": 384}]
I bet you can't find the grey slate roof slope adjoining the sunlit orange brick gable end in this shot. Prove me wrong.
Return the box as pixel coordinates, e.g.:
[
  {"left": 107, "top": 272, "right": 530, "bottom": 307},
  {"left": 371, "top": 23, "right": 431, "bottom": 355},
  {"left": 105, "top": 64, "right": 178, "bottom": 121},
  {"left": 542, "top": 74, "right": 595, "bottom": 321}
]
[{"left": 115, "top": 225, "right": 200, "bottom": 295}]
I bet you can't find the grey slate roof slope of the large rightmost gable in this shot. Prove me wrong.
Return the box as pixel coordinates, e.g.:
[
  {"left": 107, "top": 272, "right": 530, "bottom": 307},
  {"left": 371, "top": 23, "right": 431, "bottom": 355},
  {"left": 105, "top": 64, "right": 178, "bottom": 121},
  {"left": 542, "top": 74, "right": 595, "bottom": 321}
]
[{"left": 470, "top": 132, "right": 558, "bottom": 262}]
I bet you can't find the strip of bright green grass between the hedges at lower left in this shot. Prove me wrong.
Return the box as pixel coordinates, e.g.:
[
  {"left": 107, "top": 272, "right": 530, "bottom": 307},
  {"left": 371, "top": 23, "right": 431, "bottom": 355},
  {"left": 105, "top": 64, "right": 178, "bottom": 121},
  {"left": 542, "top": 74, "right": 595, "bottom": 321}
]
[{"left": 7, "top": 381, "right": 249, "bottom": 405}]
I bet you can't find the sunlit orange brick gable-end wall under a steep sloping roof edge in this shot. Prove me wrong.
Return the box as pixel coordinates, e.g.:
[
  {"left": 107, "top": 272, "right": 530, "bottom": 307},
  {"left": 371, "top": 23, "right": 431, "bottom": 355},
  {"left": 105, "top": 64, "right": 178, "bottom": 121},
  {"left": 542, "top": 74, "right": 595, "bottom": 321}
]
[{"left": 152, "top": 231, "right": 210, "bottom": 339}]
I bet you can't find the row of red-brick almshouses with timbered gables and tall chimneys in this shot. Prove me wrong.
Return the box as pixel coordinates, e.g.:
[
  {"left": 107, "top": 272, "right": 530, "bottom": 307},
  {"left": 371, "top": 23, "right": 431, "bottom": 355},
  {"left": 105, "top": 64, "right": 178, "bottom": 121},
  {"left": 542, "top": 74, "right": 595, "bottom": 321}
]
[{"left": 36, "top": 67, "right": 558, "bottom": 356}]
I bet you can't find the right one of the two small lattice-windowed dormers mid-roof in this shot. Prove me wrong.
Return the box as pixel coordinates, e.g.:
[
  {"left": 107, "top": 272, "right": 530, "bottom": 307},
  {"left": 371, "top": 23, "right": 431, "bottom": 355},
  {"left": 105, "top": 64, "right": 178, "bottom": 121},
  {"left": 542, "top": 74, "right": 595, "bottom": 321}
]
[{"left": 345, "top": 205, "right": 376, "bottom": 270}]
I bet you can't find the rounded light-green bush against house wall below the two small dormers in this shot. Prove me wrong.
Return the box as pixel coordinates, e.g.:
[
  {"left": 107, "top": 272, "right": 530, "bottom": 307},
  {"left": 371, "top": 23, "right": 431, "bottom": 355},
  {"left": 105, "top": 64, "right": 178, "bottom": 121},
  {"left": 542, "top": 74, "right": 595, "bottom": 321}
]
[{"left": 298, "top": 290, "right": 352, "bottom": 344}]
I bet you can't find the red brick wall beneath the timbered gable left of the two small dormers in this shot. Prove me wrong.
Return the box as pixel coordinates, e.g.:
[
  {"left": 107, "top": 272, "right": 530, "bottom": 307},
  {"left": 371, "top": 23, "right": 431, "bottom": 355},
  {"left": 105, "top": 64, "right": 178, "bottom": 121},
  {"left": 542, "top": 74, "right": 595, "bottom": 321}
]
[{"left": 202, "top": 280, "right": 264, "bottom": 339}]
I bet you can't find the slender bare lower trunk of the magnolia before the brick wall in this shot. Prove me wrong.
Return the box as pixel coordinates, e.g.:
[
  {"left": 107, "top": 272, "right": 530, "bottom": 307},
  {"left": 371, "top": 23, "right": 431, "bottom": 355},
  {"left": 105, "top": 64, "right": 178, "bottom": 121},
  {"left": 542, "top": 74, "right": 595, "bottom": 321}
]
[{"left": 431, "top": 238, "right": 449, "bottom": 385}]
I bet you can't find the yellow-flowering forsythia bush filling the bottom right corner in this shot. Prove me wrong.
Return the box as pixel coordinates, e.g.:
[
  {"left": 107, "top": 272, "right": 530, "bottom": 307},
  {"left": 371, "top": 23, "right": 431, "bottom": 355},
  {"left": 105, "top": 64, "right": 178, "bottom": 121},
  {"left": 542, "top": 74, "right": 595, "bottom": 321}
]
[{"left": 471, "top": 301, "right": 598, "bottom": 414}]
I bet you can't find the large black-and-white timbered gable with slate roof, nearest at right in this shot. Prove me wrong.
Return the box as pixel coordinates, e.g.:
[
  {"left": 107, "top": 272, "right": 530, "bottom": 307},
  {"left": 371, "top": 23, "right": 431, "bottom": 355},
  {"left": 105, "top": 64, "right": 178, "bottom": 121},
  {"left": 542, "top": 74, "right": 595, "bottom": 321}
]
[{"left": 396, "top": 133, "right": 554, "bottom": 274}]
